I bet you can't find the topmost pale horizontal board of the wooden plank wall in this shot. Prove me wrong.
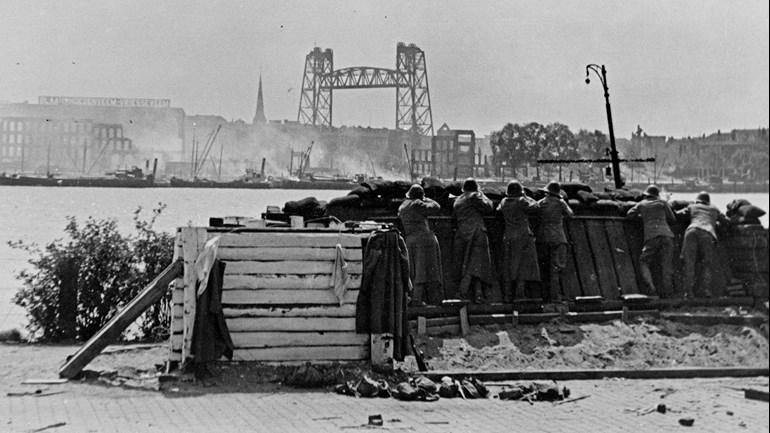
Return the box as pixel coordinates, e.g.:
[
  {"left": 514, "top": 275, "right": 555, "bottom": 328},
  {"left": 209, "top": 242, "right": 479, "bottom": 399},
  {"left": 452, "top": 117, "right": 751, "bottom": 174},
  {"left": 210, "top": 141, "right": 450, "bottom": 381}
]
[{"left": 214, "top": 232, "right": 368, "bottom": 248}]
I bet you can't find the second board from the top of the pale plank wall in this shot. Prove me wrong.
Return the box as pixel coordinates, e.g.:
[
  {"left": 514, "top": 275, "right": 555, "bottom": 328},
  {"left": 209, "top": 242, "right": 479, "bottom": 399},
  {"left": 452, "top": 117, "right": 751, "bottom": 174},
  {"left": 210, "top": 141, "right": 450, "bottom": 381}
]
[{"left": 217, "top": 246, "right": 363, "bottom": 261}]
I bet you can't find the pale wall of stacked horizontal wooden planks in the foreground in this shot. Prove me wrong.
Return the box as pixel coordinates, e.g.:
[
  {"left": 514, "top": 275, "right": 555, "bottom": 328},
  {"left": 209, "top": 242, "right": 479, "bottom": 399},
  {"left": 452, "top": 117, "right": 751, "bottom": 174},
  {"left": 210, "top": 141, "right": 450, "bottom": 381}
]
[{"left": 172, "top": 231, "right": 369, "bottom": 362}]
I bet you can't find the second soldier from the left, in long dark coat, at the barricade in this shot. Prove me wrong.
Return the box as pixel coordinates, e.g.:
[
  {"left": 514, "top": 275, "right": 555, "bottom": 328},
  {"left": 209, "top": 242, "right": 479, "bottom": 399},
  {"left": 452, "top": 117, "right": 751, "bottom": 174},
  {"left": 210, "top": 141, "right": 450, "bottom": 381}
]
[{"left": 454, "top": 178, "right": 494, "bottom": 303}]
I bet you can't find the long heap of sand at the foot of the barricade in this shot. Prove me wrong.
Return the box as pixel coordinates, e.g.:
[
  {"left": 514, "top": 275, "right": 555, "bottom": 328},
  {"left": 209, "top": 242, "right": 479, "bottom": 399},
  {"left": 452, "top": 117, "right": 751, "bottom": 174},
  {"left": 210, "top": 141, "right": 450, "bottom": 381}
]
[{"left": 419, "top": 320, "right": 769, "bottom": 370}]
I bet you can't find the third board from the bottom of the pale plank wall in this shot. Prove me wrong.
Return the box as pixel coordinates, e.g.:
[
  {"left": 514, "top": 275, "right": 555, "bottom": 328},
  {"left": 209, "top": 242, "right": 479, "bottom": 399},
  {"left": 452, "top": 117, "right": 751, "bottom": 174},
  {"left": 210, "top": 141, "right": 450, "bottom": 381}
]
[{"left": 225, "top": 317, "right": 356, "bottom": 332}]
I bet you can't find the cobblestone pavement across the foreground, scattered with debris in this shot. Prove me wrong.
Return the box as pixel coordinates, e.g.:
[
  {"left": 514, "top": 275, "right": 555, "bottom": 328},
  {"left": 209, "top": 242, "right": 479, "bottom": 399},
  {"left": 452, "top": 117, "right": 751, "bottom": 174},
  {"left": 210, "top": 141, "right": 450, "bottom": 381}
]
[{"left": 0, "top": 344, "right": 770, "bottom": 433}]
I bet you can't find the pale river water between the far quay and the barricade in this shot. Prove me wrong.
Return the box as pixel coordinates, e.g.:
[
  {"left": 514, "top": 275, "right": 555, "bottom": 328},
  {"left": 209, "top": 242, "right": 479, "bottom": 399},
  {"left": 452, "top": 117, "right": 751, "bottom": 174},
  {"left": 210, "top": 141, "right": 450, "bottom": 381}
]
[{"left": 0, "top": 186, "right": 769, "bottom": 330}]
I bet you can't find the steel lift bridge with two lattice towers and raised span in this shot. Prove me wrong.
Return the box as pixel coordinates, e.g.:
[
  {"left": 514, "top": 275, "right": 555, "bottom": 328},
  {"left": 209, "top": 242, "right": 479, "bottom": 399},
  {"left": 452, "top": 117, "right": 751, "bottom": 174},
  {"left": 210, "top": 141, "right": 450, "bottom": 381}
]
[{"left": 297, "top": 43, "right": 433, "bottom": 136}]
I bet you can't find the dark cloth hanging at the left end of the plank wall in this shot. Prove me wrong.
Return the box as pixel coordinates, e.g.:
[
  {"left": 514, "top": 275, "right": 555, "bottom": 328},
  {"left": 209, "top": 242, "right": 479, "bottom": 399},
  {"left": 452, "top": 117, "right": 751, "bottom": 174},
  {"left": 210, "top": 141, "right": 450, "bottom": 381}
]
[{"left": 192, "top": 259, "right": 235, "bottom": 372}]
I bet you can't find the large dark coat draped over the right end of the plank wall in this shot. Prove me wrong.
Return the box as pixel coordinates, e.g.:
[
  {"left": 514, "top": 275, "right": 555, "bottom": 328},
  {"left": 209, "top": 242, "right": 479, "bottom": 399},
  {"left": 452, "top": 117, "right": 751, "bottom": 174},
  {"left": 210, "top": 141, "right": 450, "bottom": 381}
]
[{"left": 356, "top": 230, "right": 412, "bottom": 361}]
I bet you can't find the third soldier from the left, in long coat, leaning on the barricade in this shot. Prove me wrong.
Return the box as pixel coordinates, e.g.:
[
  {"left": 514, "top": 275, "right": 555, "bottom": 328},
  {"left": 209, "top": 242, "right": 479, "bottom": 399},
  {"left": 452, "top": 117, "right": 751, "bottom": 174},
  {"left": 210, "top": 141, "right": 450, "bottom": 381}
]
[{"left": 497, "top": 180, "right": 540, "bottom": 303}]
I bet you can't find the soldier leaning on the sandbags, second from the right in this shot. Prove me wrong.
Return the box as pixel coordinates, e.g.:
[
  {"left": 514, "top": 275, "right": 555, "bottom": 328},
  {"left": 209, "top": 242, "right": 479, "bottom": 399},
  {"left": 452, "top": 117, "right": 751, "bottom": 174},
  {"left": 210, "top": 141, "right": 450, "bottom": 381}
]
[{"left": 626, "top": 185, "right": 676, "bottom": 297}]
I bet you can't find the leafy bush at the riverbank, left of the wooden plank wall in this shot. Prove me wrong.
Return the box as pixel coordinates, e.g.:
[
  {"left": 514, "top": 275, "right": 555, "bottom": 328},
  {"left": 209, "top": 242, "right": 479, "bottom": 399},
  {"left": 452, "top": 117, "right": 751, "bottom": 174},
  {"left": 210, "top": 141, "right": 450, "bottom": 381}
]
[{"left": 9, "top": 204, "right": 174, "bottom": 341}]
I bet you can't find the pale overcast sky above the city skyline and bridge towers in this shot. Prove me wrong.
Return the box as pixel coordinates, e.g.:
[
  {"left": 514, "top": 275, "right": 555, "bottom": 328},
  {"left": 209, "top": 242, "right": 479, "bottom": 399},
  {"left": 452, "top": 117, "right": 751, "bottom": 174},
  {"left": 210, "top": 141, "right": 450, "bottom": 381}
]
[{"left": 0, "top": 0, "right": 770, "bottom": 137}]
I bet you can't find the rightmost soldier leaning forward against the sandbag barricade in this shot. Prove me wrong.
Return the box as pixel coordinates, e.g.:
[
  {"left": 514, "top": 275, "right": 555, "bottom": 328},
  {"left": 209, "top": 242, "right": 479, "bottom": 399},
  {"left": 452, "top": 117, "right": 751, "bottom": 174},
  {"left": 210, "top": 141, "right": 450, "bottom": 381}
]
[{"left": 677, "top": 191, "right": 728, "bottom": 298}]
